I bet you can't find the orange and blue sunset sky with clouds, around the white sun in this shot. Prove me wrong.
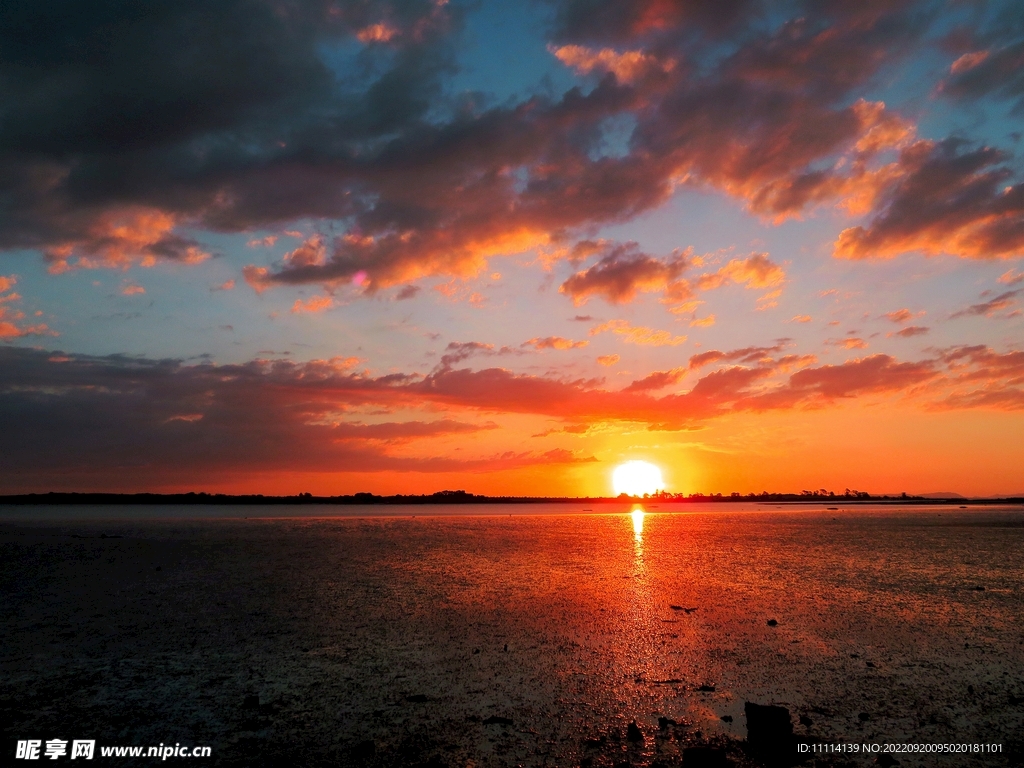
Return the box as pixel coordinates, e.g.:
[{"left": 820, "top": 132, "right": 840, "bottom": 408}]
[{"left": 0, "top": 0, "right": 1024, "bottom": 496}]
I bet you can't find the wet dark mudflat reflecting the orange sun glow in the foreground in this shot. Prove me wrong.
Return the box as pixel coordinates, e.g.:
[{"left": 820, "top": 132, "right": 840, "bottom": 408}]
[{"left": 0, "top": 505, "right": 1024, "bottom": 767}]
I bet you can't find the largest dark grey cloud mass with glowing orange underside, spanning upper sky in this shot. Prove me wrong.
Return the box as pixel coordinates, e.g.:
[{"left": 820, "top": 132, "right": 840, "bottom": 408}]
[{"left": 0, "top": 0, "right": 966, "bottom": 290}]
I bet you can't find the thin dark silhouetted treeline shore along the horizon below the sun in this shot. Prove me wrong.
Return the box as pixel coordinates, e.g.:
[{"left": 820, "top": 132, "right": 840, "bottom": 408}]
[{"left": 0, "top": 490, "right": 1024, "bottom": 507}]
